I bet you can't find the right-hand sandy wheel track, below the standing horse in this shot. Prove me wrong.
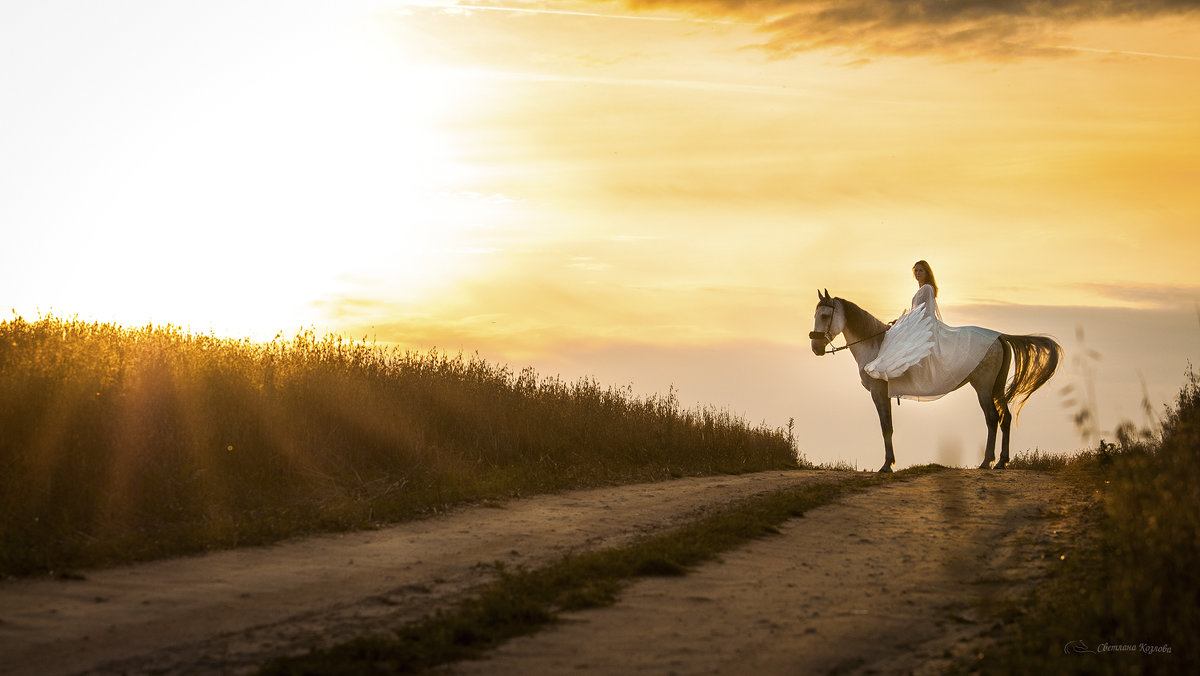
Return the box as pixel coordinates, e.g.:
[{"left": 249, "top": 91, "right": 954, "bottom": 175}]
[{"left": 449, "top": 471, "right": 1081, "bottom": 676}]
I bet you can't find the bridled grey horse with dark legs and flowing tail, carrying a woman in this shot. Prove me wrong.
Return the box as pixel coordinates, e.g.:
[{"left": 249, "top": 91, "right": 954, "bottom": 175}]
[{"left": 809, "top": 291, "right": 1062, "bottom": 472}]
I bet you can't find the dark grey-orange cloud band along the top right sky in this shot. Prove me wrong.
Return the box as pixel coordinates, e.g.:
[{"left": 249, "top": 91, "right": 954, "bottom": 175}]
[{"left": 609, "top": 0, "right": 1200, "bottom": 58}]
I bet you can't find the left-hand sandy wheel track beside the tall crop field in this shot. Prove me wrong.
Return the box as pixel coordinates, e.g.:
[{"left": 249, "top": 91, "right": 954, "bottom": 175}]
[{"left": 0, "top": 472, "right": 847, "bottom": 675}]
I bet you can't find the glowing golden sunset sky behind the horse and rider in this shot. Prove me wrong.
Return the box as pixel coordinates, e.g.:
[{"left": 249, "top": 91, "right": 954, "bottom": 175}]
[{"left": 0, "top": 0, "right": 1200, "bottom": 468}]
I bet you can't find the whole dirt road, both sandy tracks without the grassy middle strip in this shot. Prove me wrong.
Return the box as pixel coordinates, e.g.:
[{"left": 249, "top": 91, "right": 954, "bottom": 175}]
[{"left": 0, "top": 471, "right": 1073, "bottom": 675}]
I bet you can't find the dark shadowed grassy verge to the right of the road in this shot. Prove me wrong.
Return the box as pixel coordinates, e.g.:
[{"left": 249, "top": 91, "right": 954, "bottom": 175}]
[{"left": 964, "top": 369, "right": 1200, "bottom": 675}]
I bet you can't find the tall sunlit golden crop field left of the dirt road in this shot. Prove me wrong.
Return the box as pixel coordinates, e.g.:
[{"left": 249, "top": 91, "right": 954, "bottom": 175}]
[{"left": 0, "top": 317, "right": 799, "bottom": 575}]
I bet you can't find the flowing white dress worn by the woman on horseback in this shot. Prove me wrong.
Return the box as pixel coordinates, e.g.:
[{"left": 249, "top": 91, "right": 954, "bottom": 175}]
[{"left": 863, "top": 285, "right": 1001, "bottom": 401}]
